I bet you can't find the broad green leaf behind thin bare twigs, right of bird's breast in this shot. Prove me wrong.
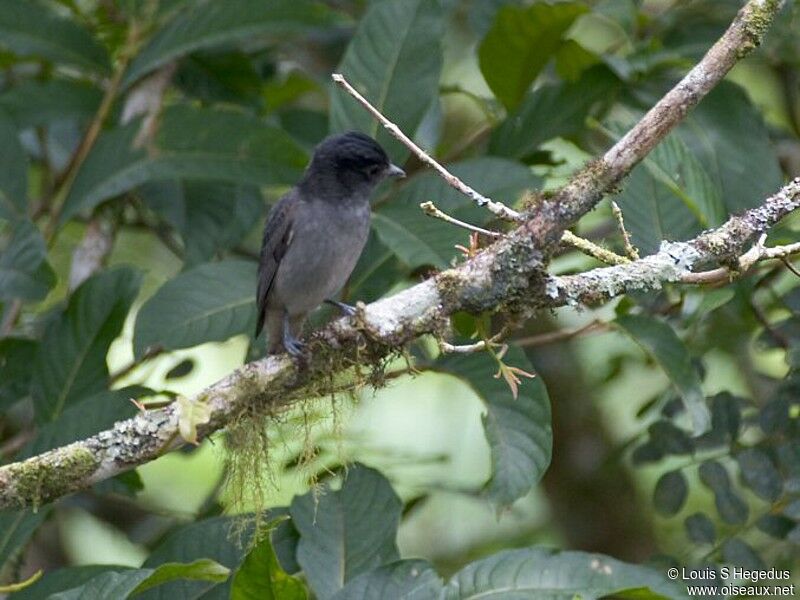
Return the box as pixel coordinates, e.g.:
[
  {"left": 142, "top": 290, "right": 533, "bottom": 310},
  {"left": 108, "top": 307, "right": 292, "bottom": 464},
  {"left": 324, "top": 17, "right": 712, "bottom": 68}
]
[{"left": 372, "top": 157, "right": 538, "bottom": 268}]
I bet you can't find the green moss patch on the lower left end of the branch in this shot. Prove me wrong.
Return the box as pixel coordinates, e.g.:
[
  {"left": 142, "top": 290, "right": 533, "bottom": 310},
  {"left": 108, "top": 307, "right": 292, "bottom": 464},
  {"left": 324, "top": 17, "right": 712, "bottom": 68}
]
[{"left": 7, "top": 444, "right": 98, "bottom": 508}]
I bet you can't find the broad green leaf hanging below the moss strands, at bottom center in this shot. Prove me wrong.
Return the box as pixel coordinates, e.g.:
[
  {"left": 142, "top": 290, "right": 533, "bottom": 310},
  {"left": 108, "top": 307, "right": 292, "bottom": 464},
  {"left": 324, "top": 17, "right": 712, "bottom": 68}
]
[{"left": 290, "top": 465, "right": 402, "bottom": 600}]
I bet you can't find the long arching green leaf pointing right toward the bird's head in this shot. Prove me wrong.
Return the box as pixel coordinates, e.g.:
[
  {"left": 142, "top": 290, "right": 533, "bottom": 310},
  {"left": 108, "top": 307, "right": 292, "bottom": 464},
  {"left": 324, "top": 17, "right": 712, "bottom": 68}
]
[{"left": 61, "top": 106, "right": 306, "bottom": 222}]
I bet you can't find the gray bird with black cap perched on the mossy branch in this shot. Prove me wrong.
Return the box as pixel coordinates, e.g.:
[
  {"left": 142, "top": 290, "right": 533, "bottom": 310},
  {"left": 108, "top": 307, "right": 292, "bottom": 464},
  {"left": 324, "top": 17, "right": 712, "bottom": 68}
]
[{"left": 256, "top": 132, "right": 405, "bottom": 356}]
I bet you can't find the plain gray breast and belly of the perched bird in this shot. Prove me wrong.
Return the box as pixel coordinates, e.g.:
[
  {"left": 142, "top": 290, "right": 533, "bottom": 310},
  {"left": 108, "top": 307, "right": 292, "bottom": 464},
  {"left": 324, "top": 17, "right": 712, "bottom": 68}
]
[{"left": 274, "top": 202, "right": 370, "bottom": 314}]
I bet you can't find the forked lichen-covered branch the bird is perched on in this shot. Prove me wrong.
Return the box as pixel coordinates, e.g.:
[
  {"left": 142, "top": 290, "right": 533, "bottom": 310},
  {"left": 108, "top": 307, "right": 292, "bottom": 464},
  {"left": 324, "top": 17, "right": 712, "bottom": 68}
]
[{"left": 0, "top": 0, "right": 780, "bottom": 507}]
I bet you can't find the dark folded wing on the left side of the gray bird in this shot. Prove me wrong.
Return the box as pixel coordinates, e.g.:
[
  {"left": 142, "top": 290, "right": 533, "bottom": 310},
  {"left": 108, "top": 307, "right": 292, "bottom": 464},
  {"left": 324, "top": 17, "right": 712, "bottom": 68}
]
[{"left": 256, "top": 192, "right": 297, "bottom": 336}]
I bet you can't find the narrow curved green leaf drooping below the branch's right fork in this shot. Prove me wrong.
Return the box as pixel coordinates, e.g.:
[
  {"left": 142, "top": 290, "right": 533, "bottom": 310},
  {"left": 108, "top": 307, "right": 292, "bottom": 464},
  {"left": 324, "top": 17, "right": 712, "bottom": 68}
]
[{"left": 617, "top": 314, "right": 711, "bottom": 435}]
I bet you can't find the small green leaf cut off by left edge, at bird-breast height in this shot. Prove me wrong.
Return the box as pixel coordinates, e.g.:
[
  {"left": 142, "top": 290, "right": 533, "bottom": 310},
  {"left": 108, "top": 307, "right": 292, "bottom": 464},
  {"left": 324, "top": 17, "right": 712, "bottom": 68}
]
[{"left": 0, "top": 220, "right": 55, "bottom": 300}]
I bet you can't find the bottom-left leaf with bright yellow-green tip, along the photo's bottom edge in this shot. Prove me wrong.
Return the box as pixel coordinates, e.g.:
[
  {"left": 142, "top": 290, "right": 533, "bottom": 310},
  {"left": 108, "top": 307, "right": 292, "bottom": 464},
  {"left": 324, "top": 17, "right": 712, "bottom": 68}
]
[{"left": 50, "top": 558, "right": 230, "bottom": 600}]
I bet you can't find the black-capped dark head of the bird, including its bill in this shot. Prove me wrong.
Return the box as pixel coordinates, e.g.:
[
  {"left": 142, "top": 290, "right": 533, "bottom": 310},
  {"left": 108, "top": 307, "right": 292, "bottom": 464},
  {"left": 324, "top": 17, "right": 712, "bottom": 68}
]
[{"left": 303, "top": 131, "right": 405, "bottom": 196}]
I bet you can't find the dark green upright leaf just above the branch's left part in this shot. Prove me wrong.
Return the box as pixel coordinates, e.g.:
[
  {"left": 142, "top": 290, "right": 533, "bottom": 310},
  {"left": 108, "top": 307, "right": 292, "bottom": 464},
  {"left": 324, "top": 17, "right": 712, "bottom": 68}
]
[{"left": 32, "top": 267, "right": 141, "bottom": 423}]
